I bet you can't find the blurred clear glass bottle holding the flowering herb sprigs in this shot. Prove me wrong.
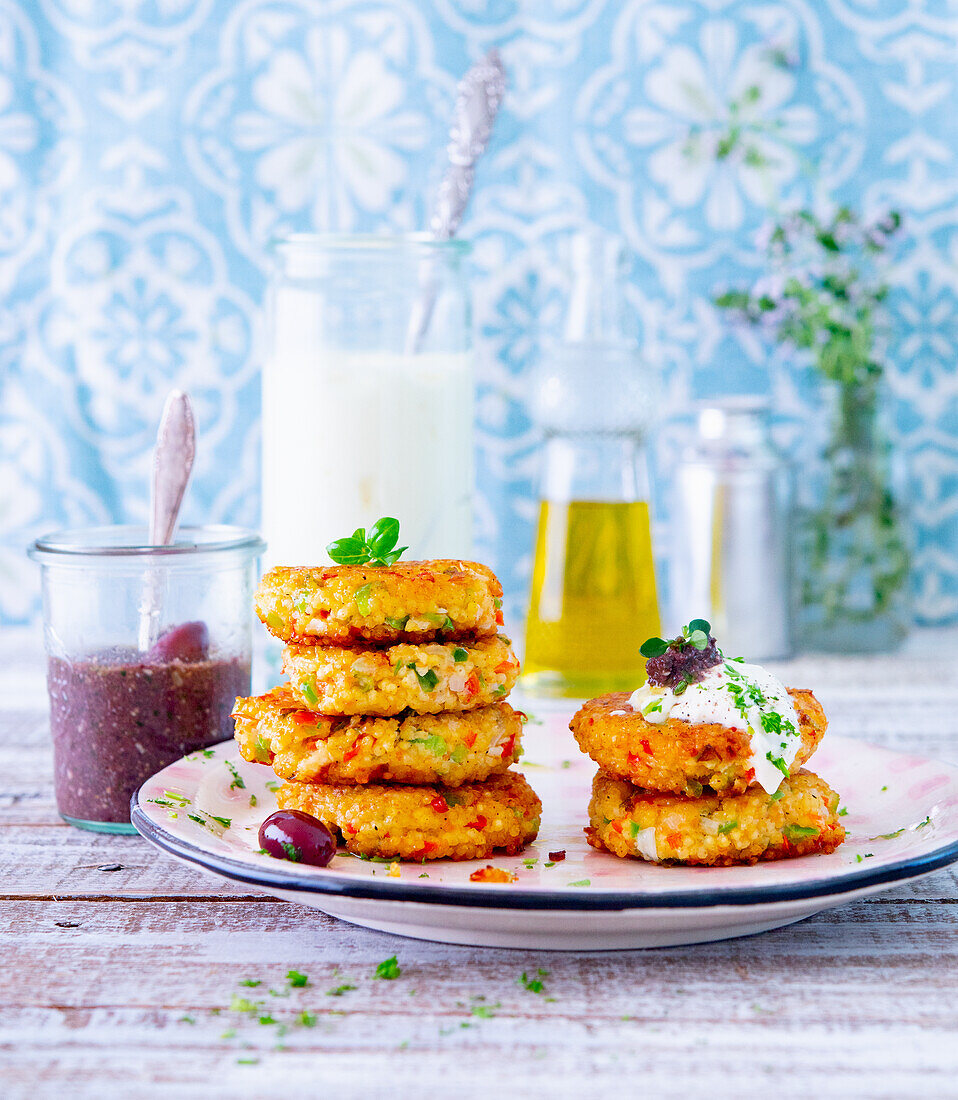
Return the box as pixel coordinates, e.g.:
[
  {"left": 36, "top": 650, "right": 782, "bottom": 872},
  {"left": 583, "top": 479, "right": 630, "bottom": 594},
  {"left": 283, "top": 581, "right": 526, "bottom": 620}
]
[{"left": 795, "top": 380, "right": 912, "bottom": 653}]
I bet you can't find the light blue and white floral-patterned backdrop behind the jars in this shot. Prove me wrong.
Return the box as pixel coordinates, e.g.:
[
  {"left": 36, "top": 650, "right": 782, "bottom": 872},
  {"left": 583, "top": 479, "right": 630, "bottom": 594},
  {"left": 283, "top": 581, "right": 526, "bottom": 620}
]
[{"left": 0, "top": 0, "right": 958, "bottom": 622}]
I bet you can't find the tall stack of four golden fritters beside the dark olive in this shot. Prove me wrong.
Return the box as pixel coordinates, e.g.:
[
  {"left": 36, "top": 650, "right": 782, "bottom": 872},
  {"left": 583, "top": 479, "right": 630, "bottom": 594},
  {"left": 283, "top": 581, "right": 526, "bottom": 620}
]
[{"left": 233, "top": 561, "right": 541, "bottom": 860}]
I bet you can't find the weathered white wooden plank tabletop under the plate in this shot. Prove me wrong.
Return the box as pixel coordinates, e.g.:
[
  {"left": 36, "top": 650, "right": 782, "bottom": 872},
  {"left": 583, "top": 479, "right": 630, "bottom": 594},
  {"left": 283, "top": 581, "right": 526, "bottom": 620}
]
[{"left": 0, "top": 639, "right": 958, "bottom": 1100}]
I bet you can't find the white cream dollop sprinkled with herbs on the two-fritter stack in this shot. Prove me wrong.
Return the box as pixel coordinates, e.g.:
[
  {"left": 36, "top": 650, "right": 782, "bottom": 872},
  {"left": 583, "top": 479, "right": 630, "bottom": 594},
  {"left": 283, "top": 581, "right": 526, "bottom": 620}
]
[{"left": 629, "top": 660, "right": 802, "bottom": 794}]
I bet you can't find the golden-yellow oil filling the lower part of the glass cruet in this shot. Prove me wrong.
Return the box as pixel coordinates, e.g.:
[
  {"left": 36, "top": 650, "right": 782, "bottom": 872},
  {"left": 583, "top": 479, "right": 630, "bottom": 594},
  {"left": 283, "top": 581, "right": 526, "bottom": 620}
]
[{"left": 522, "top": 501, "right": 661, "bottom": 696}]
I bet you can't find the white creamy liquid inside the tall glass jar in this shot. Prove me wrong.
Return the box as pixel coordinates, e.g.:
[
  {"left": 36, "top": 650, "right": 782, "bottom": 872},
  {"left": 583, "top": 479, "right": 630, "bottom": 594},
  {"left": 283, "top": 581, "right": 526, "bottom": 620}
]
[{"left": 263, "top": 287, "right": 473, "bottom": 565}]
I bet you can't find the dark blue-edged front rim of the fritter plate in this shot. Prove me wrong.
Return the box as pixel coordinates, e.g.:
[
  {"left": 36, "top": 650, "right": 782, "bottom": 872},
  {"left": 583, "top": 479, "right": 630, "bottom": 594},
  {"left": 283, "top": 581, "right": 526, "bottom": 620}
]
[{"left": 130, "top": 790, "right": 958, "bottom": 912}]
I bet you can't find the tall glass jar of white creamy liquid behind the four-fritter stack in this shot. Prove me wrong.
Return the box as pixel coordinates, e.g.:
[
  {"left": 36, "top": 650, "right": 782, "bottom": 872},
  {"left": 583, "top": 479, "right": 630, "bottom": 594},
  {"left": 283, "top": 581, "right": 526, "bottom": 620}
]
[{"left": 263, "top": 234, "right": 473, "bottom": 564}]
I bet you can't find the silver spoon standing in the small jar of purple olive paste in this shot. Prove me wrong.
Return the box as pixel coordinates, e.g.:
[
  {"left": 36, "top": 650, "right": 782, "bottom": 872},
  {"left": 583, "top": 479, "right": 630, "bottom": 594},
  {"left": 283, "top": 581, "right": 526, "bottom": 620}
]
[{"left": 137, "top": 389, "right": 196, "bottom": 652}]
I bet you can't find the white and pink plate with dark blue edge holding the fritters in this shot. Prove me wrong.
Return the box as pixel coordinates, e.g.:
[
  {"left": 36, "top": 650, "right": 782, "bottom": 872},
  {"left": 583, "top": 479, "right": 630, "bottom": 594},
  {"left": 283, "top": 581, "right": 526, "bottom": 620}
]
[{"left": 132, "top": 708, "right": 958, "bottom": 950}]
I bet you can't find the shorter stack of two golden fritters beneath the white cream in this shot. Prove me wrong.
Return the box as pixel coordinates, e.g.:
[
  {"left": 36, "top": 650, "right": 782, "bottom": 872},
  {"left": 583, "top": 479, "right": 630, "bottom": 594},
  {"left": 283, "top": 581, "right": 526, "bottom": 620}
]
[{"left": 570, "top": 688, "right": 845, "bottom": 867}]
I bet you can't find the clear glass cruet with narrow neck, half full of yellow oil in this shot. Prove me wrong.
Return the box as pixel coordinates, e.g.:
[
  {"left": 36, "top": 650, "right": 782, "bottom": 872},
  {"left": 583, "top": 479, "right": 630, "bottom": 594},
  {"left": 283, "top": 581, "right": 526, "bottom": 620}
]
[{"left": 522, "top": 231, "right": 660, "bottom": 697}]
